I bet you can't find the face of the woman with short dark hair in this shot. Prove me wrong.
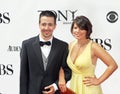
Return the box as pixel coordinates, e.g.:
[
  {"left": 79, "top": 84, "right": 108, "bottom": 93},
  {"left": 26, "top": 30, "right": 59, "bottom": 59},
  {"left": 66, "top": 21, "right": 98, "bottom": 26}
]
[{"left": 72, "top": 23, "right": 86, "bottom": 40}]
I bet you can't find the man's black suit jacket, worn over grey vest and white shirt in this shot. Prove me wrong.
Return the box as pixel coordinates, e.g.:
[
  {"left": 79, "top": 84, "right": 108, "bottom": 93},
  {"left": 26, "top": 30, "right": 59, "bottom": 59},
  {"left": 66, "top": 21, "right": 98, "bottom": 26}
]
[{"left": 20, "top": 36, "right": 71, "bottom": 94}]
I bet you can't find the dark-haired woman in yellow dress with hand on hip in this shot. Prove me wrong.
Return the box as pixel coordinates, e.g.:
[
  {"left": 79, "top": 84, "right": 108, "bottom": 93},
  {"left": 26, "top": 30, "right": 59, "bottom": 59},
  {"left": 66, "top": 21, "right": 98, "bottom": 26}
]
[{"left": 59, "top": 16, "right": 118, "bottom": 94}]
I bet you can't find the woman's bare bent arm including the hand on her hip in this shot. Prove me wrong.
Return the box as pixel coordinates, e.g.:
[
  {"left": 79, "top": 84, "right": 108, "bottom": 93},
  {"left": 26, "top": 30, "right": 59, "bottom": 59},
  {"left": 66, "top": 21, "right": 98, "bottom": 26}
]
[{"left": 83, "top": 43, "right": 118, "bottom": 86}]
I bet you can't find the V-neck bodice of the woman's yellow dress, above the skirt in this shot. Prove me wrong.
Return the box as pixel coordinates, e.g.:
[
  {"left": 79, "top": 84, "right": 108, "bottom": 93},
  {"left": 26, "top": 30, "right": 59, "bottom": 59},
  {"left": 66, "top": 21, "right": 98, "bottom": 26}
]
[{"left": 67, "top": 41, "right": 95, "bottom": 75}]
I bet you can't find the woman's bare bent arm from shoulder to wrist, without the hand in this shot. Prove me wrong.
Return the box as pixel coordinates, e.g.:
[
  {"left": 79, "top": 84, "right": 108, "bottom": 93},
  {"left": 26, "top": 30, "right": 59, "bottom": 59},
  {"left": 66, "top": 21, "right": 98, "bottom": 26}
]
[{"left": 93, "top": 43, "right": 118, "bottom": 84}]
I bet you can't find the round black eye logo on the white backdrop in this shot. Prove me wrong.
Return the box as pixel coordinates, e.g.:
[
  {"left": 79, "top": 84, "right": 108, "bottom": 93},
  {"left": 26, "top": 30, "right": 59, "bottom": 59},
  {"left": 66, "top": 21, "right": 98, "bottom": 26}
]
[{"left": 106, "top": 11, "right": 118, "bottom": 23}]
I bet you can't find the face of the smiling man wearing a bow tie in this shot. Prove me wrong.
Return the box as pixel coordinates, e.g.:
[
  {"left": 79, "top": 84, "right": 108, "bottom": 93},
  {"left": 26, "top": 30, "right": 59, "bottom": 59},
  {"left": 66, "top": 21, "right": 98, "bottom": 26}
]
[{"left": 39, "top": 16, "right": 56, "bottom": 39}]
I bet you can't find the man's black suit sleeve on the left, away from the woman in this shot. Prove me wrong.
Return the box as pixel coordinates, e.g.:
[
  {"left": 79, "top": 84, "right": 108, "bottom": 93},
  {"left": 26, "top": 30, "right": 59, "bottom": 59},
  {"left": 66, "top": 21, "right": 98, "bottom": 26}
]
[{"left": 20, "top": 42, "right": 29, "bottom": 94}]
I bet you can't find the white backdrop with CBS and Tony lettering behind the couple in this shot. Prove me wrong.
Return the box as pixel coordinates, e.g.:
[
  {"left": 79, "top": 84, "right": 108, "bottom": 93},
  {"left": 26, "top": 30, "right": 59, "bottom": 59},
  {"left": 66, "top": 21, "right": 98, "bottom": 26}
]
[{"left": 0, "top": 0, "right": 120, "bottom": 94}]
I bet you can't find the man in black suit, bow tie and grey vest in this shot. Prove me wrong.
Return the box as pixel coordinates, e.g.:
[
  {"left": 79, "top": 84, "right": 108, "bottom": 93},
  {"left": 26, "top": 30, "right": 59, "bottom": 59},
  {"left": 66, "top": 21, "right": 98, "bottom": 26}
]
[{"left": 20, "top": 10, "right": 71, "bottom": 94}]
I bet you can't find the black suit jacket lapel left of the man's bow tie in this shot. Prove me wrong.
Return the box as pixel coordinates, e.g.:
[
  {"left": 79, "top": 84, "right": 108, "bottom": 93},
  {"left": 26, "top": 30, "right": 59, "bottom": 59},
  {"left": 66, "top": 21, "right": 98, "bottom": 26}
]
[{"left": 33, "top": 36, "right": 44, "bottom": 70}]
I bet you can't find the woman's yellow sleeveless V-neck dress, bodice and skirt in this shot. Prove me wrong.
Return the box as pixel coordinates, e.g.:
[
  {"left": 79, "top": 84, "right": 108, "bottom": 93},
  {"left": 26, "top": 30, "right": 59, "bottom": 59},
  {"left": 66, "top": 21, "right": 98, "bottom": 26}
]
[{"left": 67, "top": 41, "right": 103, "bottom": 94}]
